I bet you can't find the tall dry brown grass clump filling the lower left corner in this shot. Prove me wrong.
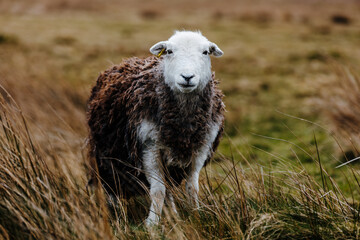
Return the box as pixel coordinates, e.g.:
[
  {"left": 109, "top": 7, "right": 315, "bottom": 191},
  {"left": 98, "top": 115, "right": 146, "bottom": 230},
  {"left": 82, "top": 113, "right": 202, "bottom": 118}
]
[{"left": 0, "top": 89, "right": 111, "bottom": 239}]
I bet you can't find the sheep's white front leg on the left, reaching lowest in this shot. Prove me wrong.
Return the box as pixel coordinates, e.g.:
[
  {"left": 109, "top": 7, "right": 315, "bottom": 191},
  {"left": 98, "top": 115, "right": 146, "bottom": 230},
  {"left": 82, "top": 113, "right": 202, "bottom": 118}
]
[{"left": 143, "top": 147, "right": 166, "bottom": 226}]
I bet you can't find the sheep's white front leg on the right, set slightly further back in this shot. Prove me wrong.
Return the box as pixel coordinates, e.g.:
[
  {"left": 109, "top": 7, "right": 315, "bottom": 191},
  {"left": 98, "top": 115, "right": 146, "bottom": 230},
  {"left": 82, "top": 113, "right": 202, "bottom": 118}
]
[{"left": 186, "top": 146, "right": 210, "bottom": 208}]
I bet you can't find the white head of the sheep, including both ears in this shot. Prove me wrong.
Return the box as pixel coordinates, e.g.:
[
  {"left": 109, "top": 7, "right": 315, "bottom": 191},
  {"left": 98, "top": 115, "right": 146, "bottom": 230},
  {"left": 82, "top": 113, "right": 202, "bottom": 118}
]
[{"left": 150, "top": 31, "right": 223, "bottom": 93}]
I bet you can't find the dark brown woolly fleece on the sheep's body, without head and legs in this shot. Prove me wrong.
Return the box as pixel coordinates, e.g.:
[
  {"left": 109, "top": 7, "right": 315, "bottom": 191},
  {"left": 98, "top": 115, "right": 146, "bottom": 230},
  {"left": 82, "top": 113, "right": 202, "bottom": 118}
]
[{"left": 87, "top": 57, "right": 224, "bottom": 197}]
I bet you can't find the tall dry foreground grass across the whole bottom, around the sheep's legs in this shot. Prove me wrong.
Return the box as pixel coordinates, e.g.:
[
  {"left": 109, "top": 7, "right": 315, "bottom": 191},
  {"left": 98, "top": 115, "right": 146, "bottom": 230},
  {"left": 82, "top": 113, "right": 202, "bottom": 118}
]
[{"left": 0, "top": 84, "right": 360, "bottom": 239}]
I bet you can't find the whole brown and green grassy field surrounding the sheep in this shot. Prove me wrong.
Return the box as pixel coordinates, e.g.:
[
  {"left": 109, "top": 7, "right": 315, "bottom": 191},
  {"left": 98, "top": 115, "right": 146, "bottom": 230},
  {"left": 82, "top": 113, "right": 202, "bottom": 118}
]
[{"left": 0, "top": 0, "right": 360, "bottom": 239}]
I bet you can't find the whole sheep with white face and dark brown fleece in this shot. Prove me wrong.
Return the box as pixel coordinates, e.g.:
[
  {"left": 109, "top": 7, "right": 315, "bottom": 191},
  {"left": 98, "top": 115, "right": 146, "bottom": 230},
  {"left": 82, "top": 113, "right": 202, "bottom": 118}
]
[{"left": 87, "top": 31, "right": 225, "bottom": 225}]
